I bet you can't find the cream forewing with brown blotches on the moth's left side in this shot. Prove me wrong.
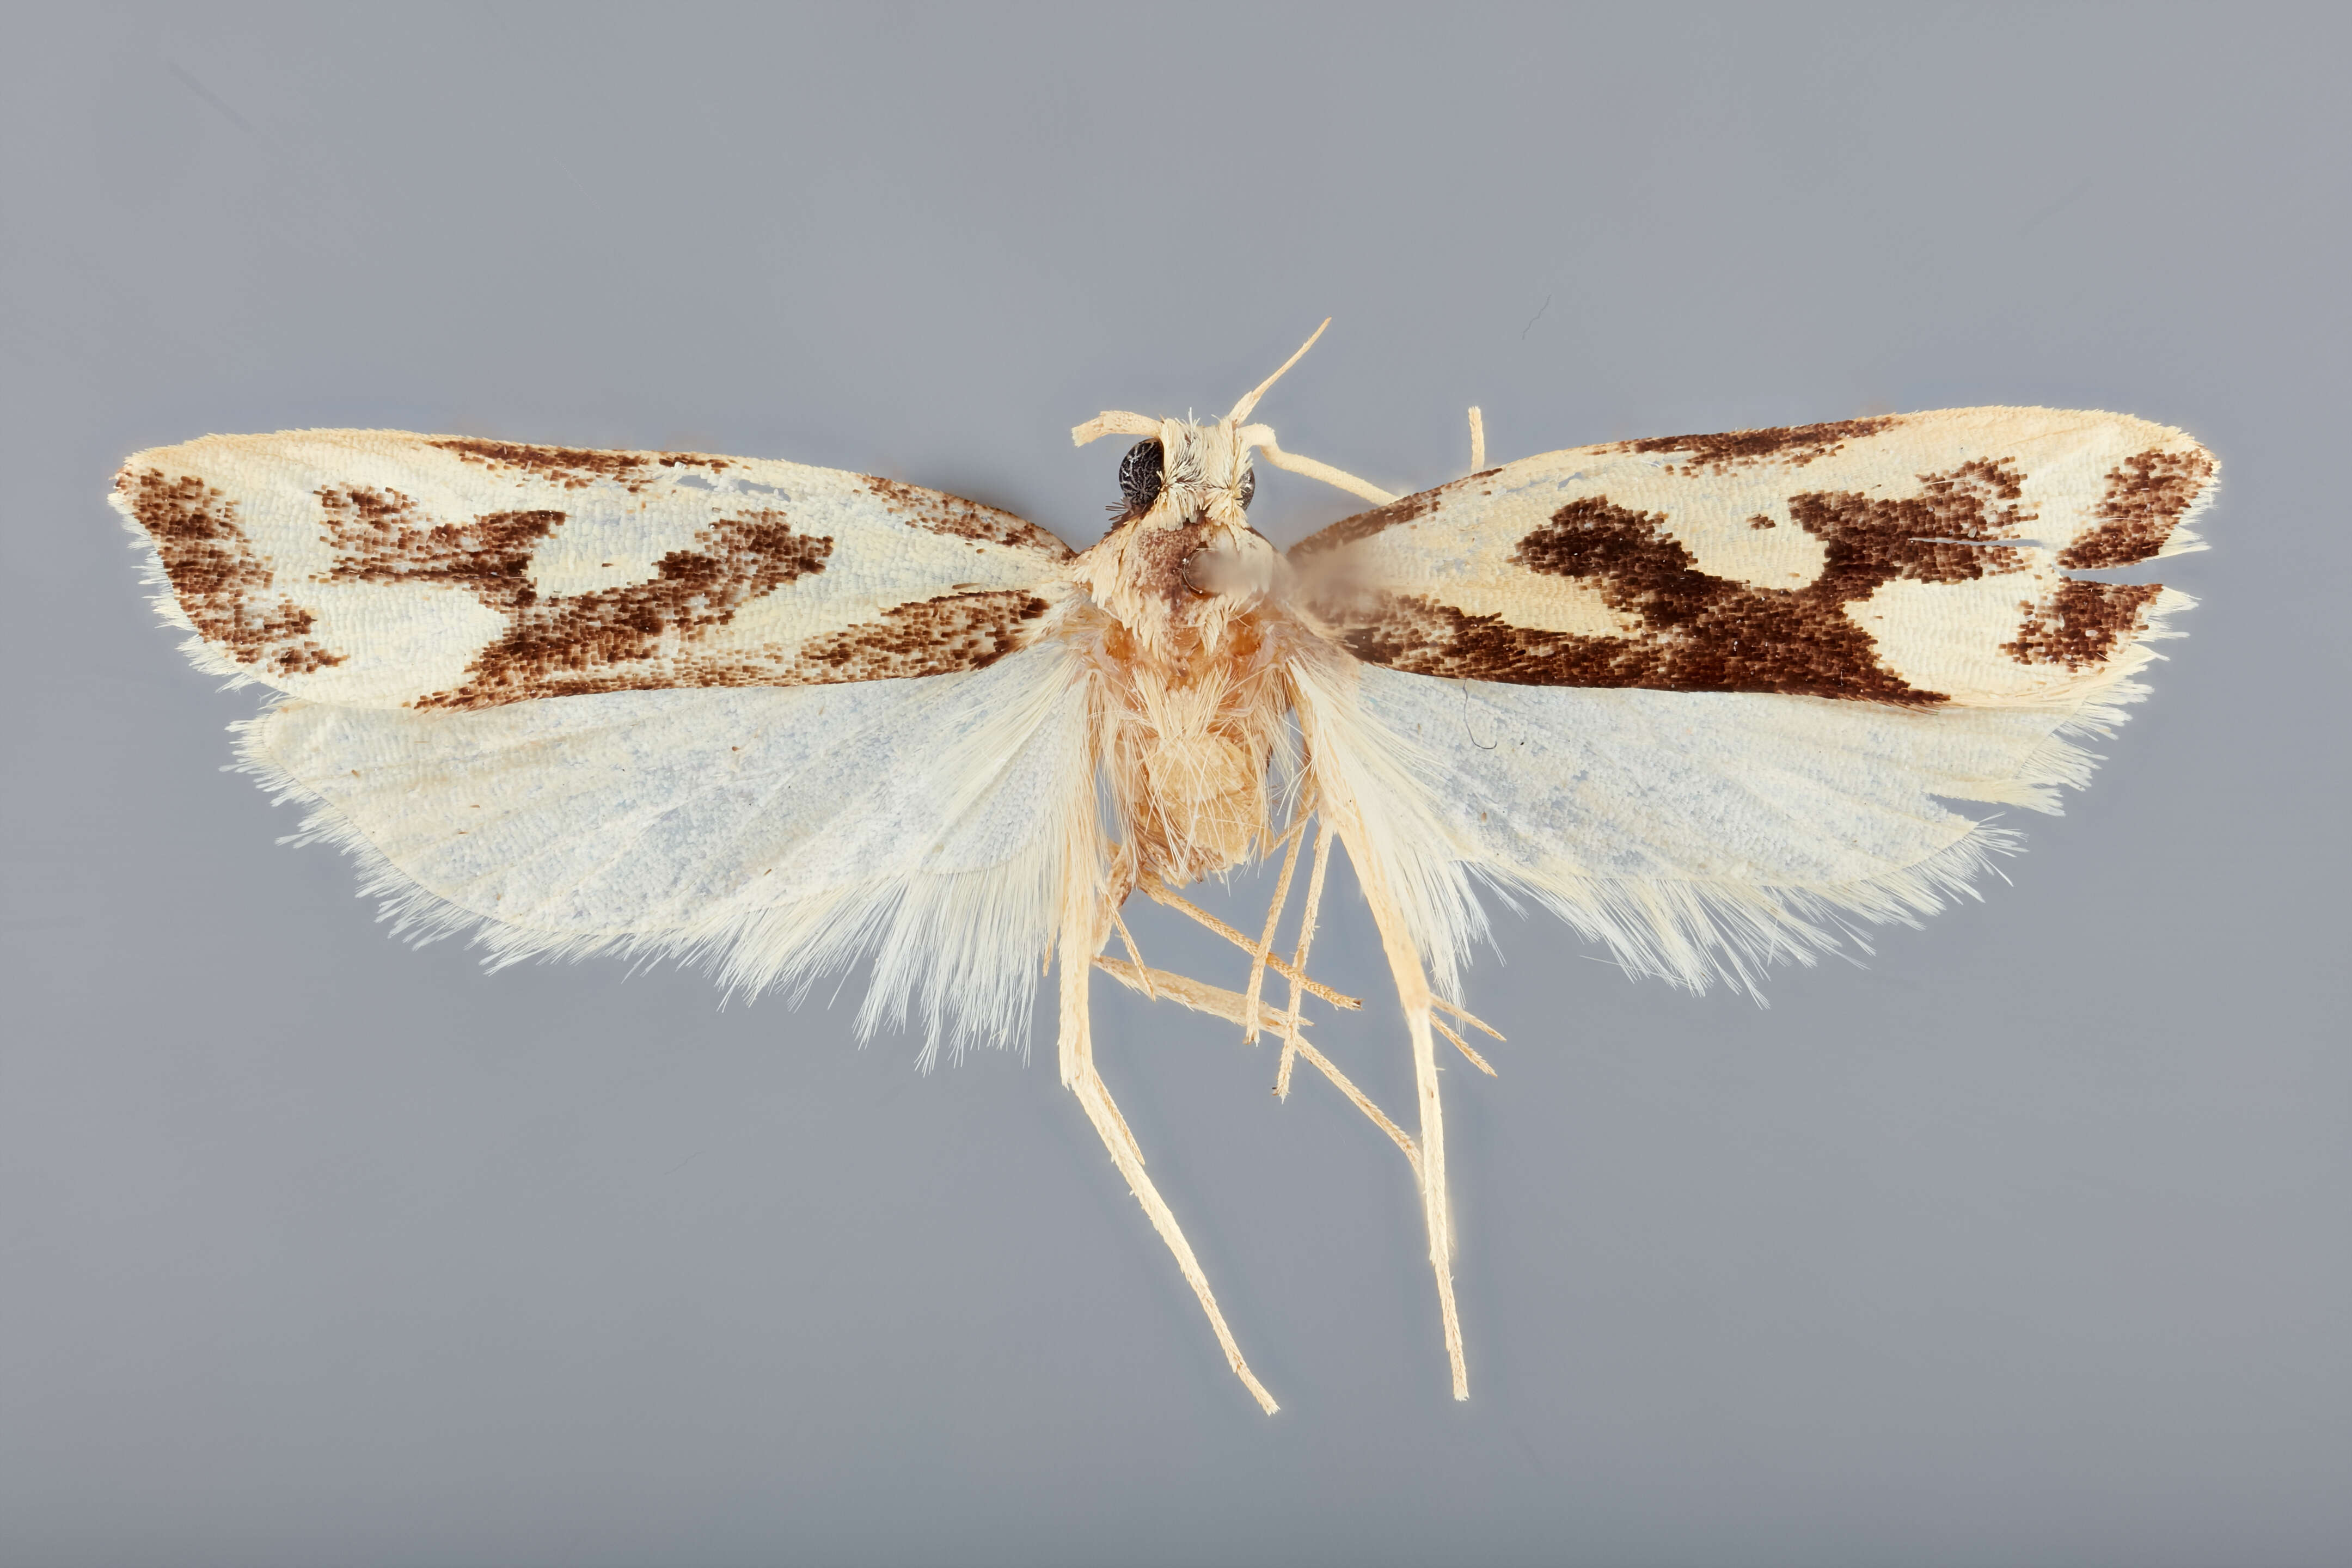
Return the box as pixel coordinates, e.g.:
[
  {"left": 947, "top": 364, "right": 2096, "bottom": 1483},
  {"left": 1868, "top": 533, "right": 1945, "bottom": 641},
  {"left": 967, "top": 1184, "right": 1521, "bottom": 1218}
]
[{"left": 113, "top": 430, "right": 1070, "bottom": 710}]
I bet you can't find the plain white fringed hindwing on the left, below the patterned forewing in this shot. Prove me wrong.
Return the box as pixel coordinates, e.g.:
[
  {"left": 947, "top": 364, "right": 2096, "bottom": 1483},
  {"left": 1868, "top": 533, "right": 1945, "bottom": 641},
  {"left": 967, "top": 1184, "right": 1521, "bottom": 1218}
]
[{"left": 240, "top": 642, "right": 1094, "bottom": 1062}]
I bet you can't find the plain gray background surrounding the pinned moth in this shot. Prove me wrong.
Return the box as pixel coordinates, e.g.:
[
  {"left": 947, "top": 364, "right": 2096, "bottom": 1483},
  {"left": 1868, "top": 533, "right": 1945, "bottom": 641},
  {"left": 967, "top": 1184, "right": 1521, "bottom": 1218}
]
[{"left": 0, "top": 7, "right": 2352, "bottom": 1566}]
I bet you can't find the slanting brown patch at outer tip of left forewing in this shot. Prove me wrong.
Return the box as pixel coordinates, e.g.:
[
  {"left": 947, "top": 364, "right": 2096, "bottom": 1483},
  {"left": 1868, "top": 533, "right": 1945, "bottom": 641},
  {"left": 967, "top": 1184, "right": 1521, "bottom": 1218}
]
[{"left": 115, "top": 468, "right": 344, "bottom": 675}]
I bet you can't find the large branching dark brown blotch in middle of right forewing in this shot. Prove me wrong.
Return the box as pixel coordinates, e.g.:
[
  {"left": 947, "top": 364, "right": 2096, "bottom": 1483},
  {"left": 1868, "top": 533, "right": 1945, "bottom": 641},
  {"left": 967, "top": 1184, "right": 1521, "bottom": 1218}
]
[{"left": 1340, "top": 463, "right": 2032, "bottom": 705}]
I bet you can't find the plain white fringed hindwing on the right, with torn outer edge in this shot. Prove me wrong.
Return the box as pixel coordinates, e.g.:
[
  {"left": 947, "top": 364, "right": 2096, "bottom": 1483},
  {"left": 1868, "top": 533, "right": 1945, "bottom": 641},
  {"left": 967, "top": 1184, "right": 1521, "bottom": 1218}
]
[{"left": 1359, "top": 670, "right": 2119, "bottom": 992}]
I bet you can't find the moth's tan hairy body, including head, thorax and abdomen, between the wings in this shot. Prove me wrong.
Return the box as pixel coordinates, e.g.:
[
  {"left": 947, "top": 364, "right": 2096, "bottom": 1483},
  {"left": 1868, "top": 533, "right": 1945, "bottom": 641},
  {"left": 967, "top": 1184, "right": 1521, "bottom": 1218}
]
[{"left": 1070, "top": 419, "right": 1296, "bottom": 886}]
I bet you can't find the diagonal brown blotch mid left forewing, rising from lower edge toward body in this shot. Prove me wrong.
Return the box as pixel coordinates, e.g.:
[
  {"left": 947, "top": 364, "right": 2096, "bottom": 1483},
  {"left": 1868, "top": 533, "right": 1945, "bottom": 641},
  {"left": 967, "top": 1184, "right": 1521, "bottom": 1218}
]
[{"left": 416, "top": 510, "right": 832, "bottom": 708}]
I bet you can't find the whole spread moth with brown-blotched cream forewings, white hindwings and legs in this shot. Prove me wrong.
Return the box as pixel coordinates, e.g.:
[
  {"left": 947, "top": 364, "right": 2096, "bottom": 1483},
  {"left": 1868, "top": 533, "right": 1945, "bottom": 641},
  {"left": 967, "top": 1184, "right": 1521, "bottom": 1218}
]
[{"left": 111, "top": 322, "right": 2218, "bottom": 1413}]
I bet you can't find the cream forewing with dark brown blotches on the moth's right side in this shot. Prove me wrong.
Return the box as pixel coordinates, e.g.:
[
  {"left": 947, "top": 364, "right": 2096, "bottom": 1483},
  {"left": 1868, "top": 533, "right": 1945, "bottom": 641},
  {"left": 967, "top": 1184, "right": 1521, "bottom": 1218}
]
[{"left": 1291, "top": 409, "right": 2218, "bottom": 708}]
